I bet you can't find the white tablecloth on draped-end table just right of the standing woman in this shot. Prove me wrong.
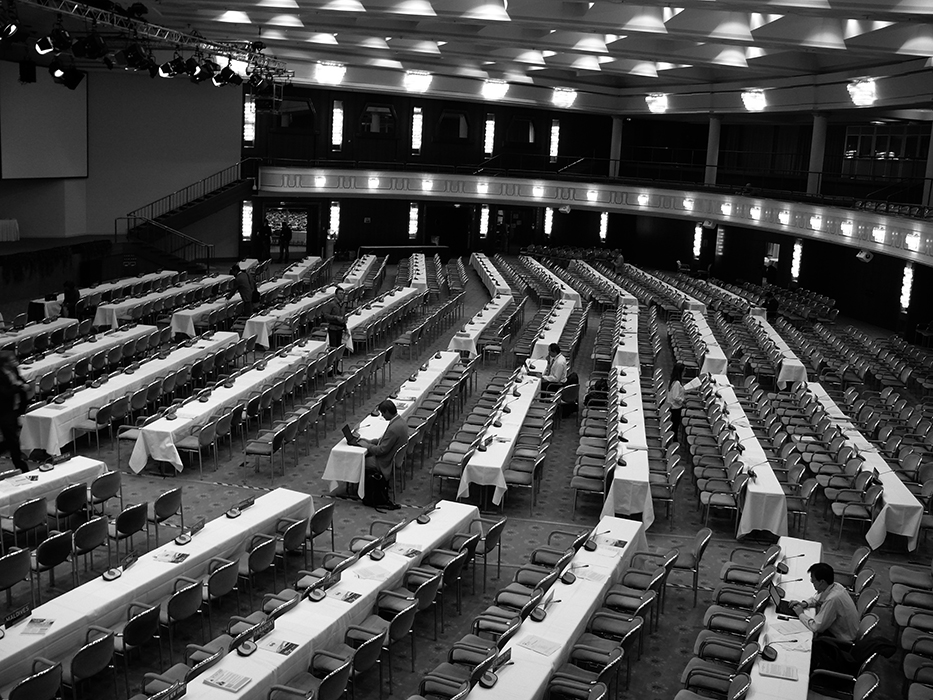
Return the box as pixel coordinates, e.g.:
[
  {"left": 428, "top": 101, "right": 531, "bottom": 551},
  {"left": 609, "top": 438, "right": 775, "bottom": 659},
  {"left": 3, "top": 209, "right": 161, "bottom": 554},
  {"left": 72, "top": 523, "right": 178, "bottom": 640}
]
[{"left": 713, "top": 374, "right": 787, "bottom": 537}]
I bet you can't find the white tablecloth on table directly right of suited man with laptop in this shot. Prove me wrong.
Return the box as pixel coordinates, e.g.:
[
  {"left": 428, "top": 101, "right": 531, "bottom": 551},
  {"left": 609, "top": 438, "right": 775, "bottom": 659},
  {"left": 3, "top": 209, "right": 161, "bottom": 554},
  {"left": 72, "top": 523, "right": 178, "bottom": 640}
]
[{"left": 457, "top": 375, "right": 541, "bottom": 505}]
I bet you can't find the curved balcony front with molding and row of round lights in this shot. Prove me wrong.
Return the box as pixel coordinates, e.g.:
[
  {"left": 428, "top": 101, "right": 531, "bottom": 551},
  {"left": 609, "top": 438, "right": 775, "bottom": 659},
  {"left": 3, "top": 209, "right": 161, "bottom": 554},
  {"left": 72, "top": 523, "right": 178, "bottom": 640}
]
[{"left": 258, "top": 167, "right": 933, "bottom": 267}]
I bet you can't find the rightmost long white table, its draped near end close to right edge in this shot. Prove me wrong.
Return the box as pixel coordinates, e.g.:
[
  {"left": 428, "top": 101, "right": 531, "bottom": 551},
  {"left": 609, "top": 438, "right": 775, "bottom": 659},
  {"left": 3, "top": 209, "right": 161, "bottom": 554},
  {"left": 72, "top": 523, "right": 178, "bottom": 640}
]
[{"left": 807, "top": 382, "right": 923, "bottom": 551}]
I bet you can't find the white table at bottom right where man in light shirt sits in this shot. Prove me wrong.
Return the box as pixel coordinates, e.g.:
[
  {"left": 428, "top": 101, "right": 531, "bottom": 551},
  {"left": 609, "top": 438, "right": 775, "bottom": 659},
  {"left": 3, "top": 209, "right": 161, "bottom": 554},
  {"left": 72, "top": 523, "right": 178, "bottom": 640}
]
[{"left": 746, "top": 537, "right": 823, "bottom": 700}]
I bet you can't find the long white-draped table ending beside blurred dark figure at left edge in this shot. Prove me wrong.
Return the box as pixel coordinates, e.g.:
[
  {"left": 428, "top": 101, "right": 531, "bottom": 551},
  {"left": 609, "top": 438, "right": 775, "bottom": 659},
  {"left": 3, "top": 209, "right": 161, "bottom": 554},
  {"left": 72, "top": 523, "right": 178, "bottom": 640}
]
[{"left": 20, "top": 333, "right": 239, "bottom": 455}]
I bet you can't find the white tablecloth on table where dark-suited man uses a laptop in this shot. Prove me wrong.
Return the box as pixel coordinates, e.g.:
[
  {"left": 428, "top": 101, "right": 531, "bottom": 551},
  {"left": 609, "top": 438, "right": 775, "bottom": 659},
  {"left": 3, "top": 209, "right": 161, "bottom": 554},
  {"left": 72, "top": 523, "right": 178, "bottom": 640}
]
[{"left": 321, "top": 352, "right": 460, "bottom": 498}]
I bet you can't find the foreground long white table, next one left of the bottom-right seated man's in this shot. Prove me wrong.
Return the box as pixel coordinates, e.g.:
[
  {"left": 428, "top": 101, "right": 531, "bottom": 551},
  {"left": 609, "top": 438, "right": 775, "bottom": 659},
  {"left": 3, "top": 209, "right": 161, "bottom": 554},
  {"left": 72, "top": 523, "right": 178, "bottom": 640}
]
[{"left": 470, "top": 517, "right": 648, "bottom": 700}]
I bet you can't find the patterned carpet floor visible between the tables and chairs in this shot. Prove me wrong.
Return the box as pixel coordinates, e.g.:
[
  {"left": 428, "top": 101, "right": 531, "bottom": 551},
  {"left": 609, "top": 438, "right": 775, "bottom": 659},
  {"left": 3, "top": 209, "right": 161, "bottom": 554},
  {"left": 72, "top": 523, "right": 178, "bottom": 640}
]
[{"left": 3, "top": 260, "right": 912, "bottom": 700}]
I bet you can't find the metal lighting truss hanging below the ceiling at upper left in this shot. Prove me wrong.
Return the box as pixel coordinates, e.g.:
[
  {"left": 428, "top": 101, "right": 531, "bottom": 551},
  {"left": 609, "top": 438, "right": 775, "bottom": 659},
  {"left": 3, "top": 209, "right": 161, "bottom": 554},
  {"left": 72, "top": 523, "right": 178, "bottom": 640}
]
[{"left": 18, "top": 0, "right": 294, "bottom": 80}]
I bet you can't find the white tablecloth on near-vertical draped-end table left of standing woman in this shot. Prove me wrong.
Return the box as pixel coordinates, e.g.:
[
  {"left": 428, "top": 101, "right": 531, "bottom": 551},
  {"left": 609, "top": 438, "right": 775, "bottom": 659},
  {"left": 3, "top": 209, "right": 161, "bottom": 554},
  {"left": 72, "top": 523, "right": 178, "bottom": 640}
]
[{"left": 602, "top": 366, "right": 654, "bottom": 530}]
